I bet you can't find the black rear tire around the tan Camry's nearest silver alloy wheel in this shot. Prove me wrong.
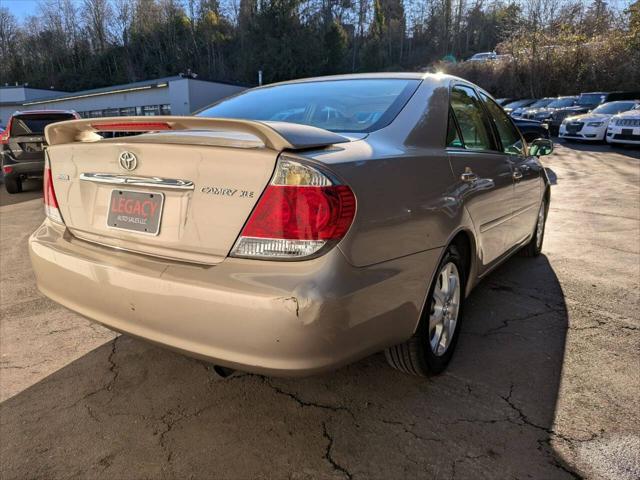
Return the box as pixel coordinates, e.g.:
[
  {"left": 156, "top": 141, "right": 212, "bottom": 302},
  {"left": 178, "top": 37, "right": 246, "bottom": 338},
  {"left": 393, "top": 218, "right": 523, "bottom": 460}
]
[{"left": 385, "top": 245, "right": 467, "bottom": 377}]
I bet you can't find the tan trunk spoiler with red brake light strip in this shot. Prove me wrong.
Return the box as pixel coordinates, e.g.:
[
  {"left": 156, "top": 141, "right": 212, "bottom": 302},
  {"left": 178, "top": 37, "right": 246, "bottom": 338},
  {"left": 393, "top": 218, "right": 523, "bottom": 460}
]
[{"left": 44, "top": 116, "right": 349, "bottom": 151}]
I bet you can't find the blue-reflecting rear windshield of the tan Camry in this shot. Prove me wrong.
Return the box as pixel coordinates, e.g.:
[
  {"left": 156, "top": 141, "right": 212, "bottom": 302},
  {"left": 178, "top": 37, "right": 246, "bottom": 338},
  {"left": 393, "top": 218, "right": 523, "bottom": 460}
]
[{"left": 198, "top": 79, "right": 420, "bottom": 133}]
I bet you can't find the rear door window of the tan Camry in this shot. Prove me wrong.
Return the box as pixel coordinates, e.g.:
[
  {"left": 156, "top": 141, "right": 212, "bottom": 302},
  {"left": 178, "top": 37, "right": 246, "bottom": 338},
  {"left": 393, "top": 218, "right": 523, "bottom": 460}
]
[{"left": 451, "top": 86, "right": 493, "bottom": 150}]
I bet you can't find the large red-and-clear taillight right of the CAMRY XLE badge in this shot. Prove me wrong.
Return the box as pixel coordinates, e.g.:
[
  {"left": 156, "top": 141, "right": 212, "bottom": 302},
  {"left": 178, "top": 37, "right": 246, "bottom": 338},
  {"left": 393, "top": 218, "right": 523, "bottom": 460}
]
[{"left": 231, "top": 157, "right": 356, "bottom": 260}]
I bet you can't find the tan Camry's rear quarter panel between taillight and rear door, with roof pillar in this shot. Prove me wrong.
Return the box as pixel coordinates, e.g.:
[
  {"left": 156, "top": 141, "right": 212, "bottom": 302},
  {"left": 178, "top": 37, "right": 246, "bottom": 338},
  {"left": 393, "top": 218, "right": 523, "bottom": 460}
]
[{"left": 312, "top": 79, "right": 461, "bottom": 267}]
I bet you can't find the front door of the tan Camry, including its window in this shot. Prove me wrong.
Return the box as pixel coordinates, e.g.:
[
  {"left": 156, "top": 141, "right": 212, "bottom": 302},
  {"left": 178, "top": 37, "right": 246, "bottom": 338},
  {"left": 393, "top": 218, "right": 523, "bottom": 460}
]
[{"left": 480, "top": 93, "right": 543, "bottom": 247}]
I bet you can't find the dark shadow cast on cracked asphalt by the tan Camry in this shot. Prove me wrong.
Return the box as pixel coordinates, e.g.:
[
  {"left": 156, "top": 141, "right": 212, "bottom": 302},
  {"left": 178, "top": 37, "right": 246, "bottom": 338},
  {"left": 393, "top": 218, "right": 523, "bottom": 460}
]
[{"left": 0, "top": 256, "right": 576, "bottom": 479}]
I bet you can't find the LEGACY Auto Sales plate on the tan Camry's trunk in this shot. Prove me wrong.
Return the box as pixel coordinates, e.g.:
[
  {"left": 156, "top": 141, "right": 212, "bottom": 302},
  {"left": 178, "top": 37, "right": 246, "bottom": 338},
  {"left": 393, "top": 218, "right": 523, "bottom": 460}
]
[{"left": 106, "top": 188, "right": 164, "bottom": 237}]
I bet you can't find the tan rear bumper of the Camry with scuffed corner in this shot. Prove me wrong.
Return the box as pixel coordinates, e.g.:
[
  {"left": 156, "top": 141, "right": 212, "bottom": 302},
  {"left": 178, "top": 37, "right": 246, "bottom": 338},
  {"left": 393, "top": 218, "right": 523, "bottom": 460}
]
[{"left": 29, "top": 220, "right": 440, "bottom": 375}]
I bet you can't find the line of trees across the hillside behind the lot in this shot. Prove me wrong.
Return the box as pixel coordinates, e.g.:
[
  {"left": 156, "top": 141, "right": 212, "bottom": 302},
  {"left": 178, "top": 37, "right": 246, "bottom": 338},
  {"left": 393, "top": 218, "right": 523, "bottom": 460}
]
[{"left": 0, "top": 0, "right": 640, "bottom": 96}]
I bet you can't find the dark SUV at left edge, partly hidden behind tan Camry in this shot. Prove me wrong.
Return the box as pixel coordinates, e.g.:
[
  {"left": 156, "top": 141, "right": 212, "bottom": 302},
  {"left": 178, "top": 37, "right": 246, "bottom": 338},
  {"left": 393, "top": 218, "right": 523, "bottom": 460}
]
[{"left": 0, "top": 110, "right": 80, "bottom": 193}]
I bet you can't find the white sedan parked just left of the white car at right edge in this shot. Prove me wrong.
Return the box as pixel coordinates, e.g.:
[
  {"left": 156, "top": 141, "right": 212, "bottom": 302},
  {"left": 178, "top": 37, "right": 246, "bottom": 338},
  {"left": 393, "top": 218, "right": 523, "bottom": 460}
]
[{"left": 558, "top": 100, "right": 640, "bottom": 142}]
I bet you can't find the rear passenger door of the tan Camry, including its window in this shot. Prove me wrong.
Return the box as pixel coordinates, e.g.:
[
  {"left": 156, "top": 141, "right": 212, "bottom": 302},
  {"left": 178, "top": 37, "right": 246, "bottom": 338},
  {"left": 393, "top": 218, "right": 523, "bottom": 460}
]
[{"left": 447, "top": 85, "right": 513, "bottom": 273}]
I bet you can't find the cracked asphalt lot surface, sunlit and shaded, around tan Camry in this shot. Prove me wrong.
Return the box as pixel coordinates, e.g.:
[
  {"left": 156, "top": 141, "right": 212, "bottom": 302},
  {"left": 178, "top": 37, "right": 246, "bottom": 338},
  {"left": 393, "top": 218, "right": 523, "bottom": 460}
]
[{"left": 0, "top": 144, "right": 640, "bottom": 480}]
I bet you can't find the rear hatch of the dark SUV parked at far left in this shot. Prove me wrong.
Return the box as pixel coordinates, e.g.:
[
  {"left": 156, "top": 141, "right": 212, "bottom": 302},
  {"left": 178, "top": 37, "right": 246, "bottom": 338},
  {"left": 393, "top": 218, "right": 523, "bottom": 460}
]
[{"left": 7, "top": 113, "right": 75, "bottom": 162}]
